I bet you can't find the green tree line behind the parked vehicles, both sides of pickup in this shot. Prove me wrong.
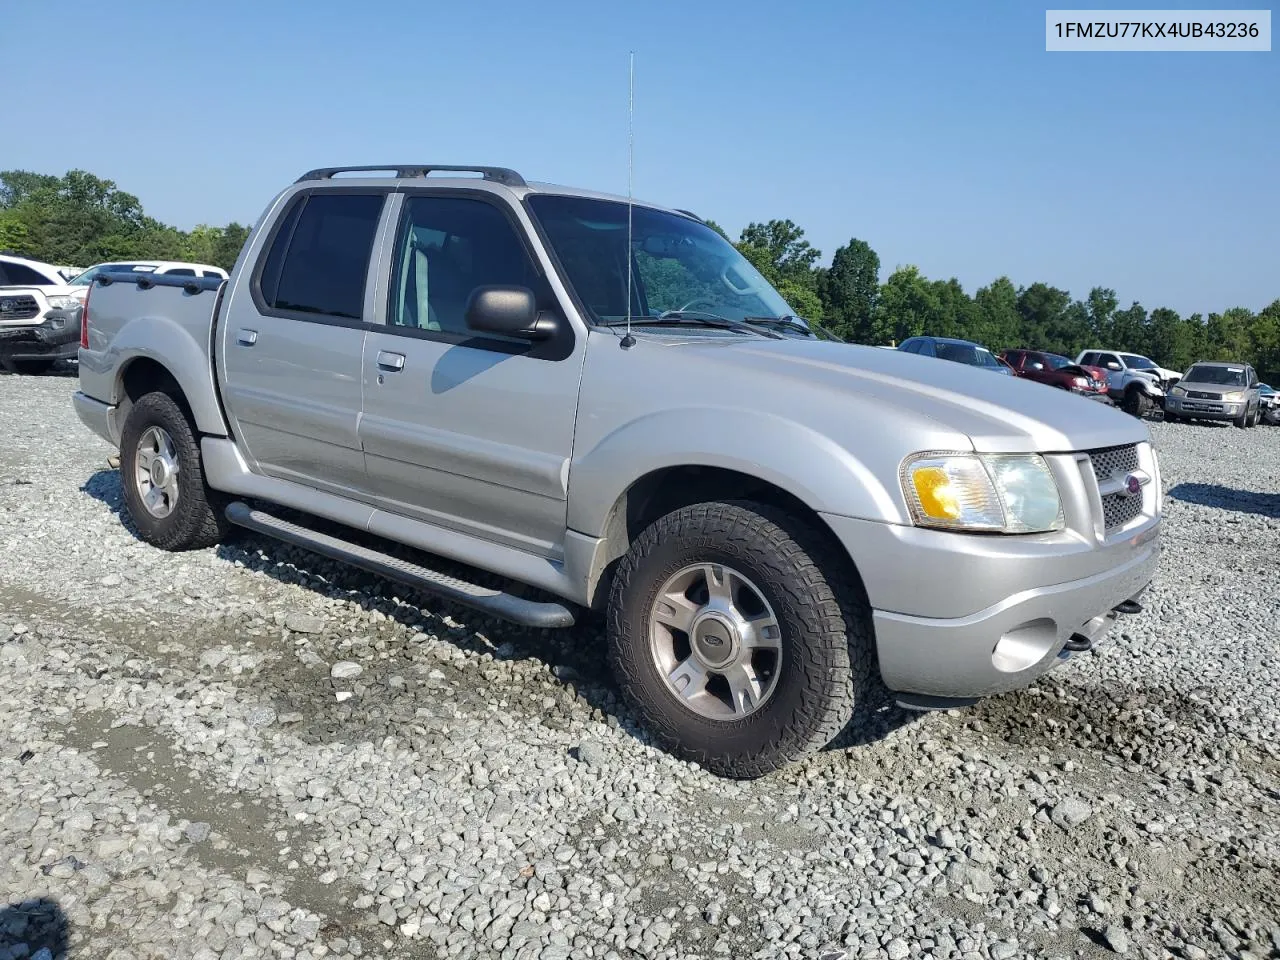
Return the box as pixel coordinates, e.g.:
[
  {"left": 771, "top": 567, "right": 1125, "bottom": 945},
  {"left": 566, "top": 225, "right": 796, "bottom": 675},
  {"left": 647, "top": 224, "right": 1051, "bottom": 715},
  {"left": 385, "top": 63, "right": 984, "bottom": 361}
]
[{"left": 0, "top": 170, "right": 1280, "bottom": 379}]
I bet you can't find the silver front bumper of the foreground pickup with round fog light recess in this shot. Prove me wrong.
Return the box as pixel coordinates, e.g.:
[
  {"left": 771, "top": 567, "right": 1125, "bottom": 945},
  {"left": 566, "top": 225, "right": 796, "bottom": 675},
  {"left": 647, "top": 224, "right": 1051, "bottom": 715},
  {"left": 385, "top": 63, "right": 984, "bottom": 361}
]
[{"left": 826, "top": 516, "right": 1160, "bottom": 699}]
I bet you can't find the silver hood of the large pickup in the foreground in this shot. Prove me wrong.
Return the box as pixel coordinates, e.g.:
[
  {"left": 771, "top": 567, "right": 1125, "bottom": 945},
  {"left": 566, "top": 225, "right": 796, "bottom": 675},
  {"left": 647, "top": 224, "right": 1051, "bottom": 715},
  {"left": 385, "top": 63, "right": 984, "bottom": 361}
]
[{"left": 706, "top": 339, "right": 1151, "bottom": 453}]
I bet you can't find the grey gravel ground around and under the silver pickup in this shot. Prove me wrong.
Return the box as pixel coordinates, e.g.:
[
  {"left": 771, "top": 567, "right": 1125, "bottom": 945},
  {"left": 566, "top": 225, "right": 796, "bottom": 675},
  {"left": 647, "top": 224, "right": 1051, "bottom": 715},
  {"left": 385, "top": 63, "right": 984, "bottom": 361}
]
[{"left": 0, "top": 376, "right": 1280, "bottom": 960}]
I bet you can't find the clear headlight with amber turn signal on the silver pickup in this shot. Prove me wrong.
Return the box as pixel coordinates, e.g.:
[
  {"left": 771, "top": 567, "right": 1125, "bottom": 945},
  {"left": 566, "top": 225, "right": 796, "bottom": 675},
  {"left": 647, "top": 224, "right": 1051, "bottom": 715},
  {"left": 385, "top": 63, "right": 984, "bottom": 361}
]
[{"left": 902, "top": 453, "right": 1064, "bottom": 534}]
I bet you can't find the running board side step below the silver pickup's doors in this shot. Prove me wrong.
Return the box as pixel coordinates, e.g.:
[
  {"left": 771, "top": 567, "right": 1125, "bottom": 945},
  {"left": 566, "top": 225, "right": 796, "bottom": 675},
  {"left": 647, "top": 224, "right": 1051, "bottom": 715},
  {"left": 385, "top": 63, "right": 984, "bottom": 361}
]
[{"left": 227, "top": 500, "right": 573, "bottom": 630}]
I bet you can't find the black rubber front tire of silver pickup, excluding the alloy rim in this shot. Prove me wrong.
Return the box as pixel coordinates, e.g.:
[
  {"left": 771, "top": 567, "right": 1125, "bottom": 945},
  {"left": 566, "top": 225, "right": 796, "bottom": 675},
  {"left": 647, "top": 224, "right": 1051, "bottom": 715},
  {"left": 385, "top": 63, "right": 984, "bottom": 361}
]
[{"left": 608, "top": 502, "right": 874, "bottom": 778}]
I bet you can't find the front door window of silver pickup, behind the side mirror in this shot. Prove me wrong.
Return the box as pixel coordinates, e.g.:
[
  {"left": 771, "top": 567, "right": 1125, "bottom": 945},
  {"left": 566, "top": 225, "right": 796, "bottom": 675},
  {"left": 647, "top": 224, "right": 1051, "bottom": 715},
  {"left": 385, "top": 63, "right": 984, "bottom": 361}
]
[{"left": 390, "top": 197, "right": 550, "bottom": 337}]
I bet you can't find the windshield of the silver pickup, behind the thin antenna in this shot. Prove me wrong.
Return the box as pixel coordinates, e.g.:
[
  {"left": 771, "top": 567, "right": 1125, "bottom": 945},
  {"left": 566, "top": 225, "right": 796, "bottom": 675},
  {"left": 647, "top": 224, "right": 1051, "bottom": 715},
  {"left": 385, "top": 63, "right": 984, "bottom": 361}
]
[{"left": 527, "top": 193, "right": 795, "bottom": 323}]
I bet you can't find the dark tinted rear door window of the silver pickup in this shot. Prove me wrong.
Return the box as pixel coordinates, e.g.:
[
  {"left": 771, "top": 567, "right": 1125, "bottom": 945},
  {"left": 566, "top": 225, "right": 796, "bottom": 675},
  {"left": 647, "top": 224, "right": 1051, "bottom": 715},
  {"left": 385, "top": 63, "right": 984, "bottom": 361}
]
[{"left": 261, "top": 193, "right": 383, "bottom": 320}]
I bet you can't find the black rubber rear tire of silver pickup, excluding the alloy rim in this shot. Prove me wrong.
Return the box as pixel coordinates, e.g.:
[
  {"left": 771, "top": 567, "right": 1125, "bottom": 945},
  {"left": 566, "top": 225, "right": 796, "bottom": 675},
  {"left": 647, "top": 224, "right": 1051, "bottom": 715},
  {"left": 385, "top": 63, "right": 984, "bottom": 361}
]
[{"left": 120, "top": 392, "right": 229, "bottom": 550}]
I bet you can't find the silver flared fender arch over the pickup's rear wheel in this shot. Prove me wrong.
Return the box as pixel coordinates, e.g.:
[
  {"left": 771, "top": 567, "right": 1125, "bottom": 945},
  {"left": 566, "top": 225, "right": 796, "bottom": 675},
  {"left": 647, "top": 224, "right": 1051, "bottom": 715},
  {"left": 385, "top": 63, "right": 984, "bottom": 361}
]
[{"left": 101, "top": 316, "right": 230, "bottom": 436}]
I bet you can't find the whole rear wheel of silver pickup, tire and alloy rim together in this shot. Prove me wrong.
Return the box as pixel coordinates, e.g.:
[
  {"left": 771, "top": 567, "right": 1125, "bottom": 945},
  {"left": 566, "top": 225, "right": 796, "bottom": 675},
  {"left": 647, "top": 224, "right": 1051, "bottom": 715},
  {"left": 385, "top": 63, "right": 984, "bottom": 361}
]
[{"left": 120, "top": 392, "right": 228, "bottom": 550}]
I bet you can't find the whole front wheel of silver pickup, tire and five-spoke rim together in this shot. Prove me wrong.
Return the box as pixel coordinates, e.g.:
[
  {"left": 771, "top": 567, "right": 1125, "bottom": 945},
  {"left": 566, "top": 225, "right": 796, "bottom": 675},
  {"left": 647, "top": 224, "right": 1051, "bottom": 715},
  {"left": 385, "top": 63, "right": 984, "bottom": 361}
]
[{"left": 608, "top": 502, "right": 873, "bottom": 778}]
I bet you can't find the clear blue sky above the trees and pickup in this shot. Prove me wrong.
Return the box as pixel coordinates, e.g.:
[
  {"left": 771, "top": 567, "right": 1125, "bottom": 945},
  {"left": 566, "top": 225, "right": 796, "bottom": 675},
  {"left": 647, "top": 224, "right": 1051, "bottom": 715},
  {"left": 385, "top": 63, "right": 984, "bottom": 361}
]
[{"left": 0, "top": 0, "right": 1280, "bottom": 312}]
